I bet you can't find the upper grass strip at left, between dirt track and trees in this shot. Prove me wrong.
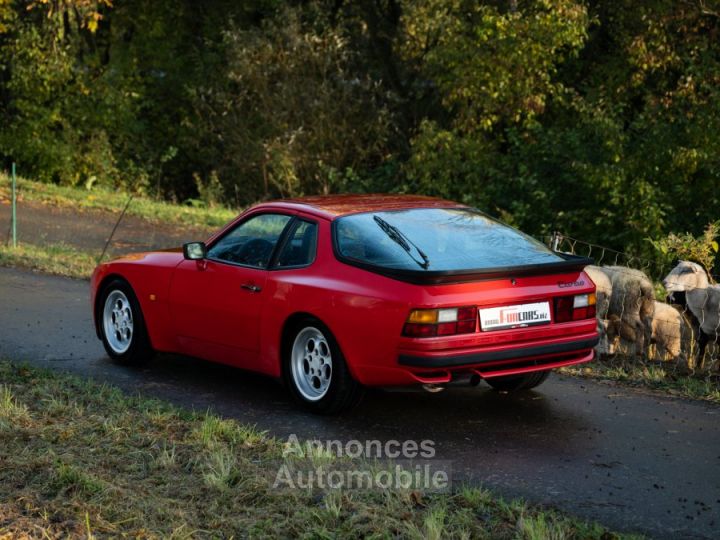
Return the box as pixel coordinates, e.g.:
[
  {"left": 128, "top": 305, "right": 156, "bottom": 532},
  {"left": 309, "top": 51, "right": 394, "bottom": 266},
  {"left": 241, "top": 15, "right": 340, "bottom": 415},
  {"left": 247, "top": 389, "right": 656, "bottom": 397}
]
[{"left": 0, "top": 172, "right": 238, "bottom": 229}]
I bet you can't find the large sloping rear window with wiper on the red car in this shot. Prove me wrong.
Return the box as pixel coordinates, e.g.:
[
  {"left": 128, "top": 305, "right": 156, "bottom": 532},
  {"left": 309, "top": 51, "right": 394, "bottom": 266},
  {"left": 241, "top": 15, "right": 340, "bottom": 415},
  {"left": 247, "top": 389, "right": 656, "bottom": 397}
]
[{"left": 333, "top": 207, "right": 592, "bottom": 285}]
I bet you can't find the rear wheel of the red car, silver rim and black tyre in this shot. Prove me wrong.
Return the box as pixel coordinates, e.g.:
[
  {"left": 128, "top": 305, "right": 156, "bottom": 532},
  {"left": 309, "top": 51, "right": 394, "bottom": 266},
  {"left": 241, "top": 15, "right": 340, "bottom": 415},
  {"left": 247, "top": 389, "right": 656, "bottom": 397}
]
[{"left": 284, "top": 319, "right": 363, "bottom": 414}]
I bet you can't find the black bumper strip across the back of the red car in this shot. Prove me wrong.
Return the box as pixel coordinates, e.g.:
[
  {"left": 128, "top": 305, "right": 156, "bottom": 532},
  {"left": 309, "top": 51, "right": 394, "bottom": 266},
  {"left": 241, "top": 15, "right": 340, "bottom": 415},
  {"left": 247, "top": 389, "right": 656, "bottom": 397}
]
[{"left": 398, "top": 336, "right": 599, "bottom": 368}]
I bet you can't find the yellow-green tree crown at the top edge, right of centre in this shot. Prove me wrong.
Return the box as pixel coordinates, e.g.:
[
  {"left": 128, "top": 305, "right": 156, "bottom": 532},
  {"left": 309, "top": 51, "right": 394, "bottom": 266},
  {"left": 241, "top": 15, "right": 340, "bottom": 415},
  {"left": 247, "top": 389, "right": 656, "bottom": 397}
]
[{"left": 404, "top": 0, "right": 588, "bottom": 133}]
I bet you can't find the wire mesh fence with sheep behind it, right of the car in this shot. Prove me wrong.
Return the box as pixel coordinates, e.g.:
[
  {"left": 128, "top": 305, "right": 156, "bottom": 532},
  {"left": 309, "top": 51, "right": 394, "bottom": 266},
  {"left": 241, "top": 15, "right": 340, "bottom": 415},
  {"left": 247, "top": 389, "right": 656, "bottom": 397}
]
[{"left": 546, "top": 233, "right": 720, "bottom": 380}]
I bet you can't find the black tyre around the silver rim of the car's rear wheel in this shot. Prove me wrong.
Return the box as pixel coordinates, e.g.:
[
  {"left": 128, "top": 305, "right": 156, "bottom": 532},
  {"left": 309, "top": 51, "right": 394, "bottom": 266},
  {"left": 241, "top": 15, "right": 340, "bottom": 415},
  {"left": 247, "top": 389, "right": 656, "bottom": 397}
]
[{"left": 282, "top": 318, "right": 364, "bottom": 415}]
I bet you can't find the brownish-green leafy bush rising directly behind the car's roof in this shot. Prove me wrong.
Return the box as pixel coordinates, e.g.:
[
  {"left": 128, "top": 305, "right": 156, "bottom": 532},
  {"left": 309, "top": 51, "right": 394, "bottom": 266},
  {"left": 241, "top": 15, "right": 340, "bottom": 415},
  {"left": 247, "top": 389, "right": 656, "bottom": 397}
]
[{"left": 197, "top": 4, "right": 400, "bottom": 201}]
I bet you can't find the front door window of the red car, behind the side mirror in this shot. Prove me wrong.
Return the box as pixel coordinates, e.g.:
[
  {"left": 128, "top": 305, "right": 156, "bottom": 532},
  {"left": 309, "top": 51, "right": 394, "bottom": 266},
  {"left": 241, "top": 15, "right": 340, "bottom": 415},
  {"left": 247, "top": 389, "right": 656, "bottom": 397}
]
[{"left": 208, "top": 214, "right": 291, "bottom": 268}]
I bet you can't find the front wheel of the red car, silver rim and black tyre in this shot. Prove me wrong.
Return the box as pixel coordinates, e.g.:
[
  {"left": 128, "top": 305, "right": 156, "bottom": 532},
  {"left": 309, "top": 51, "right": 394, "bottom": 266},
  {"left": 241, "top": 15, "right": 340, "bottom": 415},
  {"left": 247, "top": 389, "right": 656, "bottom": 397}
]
[{"left": 98, "top": 279, "right": 153, "bottom": 365}]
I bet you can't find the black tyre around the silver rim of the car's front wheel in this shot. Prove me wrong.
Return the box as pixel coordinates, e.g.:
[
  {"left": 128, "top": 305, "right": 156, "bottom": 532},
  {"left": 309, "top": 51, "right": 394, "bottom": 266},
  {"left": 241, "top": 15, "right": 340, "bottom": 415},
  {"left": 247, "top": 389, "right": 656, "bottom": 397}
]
[{"left": 96, "top": 279, "right": 154, "bottom": 366}]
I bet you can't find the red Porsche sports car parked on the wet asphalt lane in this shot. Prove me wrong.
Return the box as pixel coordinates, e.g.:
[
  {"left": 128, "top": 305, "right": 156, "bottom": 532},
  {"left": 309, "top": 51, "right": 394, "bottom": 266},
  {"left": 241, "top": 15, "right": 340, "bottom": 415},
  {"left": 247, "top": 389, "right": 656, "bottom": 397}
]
[{"left": 91, "top": 195, "right": 598, "bottom": 413}]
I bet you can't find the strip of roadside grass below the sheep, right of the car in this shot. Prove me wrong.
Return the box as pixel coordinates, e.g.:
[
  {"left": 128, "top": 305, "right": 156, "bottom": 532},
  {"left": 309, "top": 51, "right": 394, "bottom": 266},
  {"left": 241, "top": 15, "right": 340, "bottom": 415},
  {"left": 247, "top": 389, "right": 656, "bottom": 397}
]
[{"left": 560, "top": 356, "right": 720, "bottom": 403}]
